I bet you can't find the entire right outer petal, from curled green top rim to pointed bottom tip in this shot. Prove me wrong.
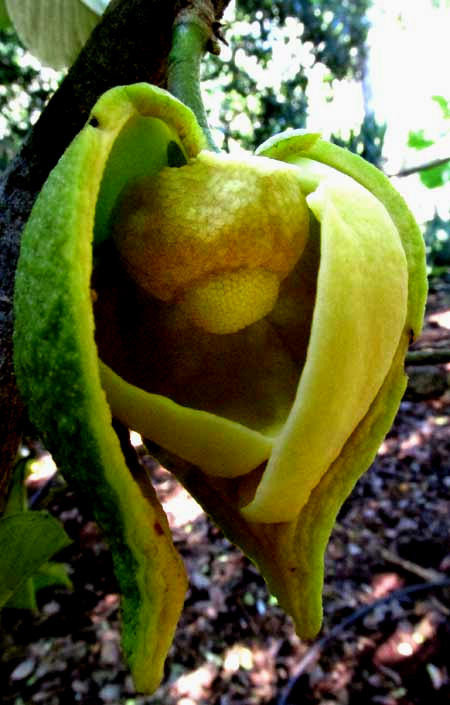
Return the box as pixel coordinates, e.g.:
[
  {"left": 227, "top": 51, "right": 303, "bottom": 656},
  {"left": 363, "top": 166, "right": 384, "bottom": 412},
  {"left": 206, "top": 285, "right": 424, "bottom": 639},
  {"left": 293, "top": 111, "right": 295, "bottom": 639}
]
[{"left": 236, "top": 132, "right": 427, "bottom": 638}]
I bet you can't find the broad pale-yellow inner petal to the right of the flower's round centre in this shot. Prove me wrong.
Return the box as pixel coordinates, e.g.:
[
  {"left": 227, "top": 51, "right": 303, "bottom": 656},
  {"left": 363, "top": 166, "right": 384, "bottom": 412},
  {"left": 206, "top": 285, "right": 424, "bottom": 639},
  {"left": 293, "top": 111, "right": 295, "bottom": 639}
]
[{"left": 242, "top": 175, "right": 408, "bottom": 522}]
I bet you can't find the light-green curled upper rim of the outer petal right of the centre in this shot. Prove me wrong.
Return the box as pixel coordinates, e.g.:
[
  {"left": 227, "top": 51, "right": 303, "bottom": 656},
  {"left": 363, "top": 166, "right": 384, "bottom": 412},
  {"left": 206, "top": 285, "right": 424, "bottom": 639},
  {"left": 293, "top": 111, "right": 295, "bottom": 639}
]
[{"left": 256, "top": 130, "right": 427, "bottom": 339}]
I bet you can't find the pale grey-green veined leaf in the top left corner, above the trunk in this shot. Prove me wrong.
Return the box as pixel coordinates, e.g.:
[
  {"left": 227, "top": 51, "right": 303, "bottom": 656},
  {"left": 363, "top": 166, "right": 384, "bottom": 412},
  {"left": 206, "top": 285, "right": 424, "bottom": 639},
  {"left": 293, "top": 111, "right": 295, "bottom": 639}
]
[{"left": 6, "top": 0, "right": 103, "bottom": 68}]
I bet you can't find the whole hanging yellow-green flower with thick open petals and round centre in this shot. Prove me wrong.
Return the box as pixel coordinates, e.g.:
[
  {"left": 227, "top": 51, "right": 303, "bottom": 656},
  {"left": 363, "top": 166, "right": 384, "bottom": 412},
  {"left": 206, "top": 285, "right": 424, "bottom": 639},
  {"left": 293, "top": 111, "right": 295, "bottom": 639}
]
[{"left": 15, "top": 84, "right": 426, "bottom": 690}]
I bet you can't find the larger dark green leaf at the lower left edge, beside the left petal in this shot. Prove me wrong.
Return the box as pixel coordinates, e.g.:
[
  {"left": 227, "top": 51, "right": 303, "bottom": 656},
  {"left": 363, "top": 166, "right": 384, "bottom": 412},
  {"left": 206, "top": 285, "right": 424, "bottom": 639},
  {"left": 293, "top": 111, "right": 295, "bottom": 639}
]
[{"left": 0, "top": 512, "right": 70, "bottom": 607}]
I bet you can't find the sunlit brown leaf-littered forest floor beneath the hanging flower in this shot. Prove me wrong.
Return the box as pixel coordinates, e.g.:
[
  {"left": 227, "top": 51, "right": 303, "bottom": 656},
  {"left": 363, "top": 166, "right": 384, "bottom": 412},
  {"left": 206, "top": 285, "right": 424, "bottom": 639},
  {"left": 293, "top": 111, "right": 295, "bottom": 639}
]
[{"left": 0, "top": 279, "right": 450, "bottom": 705}]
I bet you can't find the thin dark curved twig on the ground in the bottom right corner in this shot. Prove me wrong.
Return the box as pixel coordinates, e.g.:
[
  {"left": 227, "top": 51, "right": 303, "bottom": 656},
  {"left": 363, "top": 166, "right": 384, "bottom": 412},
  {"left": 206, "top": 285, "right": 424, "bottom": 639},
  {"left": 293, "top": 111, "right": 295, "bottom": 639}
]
[{"left": 277, "top": 578, "right": 450, "bottom": 705}]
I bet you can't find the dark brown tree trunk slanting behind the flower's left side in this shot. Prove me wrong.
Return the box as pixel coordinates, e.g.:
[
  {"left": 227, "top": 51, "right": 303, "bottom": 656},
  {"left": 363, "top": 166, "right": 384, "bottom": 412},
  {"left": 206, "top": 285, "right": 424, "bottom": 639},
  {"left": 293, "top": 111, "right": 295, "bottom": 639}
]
[{"left": 0, "top": 0, "right": 229, "bottom": 512}]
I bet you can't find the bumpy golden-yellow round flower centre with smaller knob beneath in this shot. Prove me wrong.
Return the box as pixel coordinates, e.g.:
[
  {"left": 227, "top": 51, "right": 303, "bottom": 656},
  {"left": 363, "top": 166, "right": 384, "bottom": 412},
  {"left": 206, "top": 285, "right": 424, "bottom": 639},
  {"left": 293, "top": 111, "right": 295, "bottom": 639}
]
[{"left": 113, "top": 152, "right": 309, "bottom": 334}]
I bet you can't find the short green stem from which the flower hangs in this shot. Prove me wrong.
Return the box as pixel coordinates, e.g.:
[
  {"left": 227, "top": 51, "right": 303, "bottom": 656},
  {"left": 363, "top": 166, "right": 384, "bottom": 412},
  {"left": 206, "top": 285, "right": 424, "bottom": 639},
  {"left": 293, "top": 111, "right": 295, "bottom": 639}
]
[{"left": 167, "top": 17, "right": 219, "bottom": 152}]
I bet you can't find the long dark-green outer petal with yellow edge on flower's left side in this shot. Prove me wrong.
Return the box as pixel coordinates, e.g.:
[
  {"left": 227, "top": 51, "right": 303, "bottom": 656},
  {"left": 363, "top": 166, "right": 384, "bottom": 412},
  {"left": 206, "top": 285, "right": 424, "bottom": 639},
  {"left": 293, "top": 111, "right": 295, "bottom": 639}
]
[{"left": 14, "top": 84, "right": 203, "bottom": 692}]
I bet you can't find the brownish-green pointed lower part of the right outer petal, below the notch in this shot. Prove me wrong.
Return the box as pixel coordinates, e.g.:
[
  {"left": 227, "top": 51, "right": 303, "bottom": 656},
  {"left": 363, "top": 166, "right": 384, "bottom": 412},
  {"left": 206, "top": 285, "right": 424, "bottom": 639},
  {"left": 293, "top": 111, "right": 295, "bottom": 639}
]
[{"left": 154, "top": 333, "right": 408, "bottom": 639}]
